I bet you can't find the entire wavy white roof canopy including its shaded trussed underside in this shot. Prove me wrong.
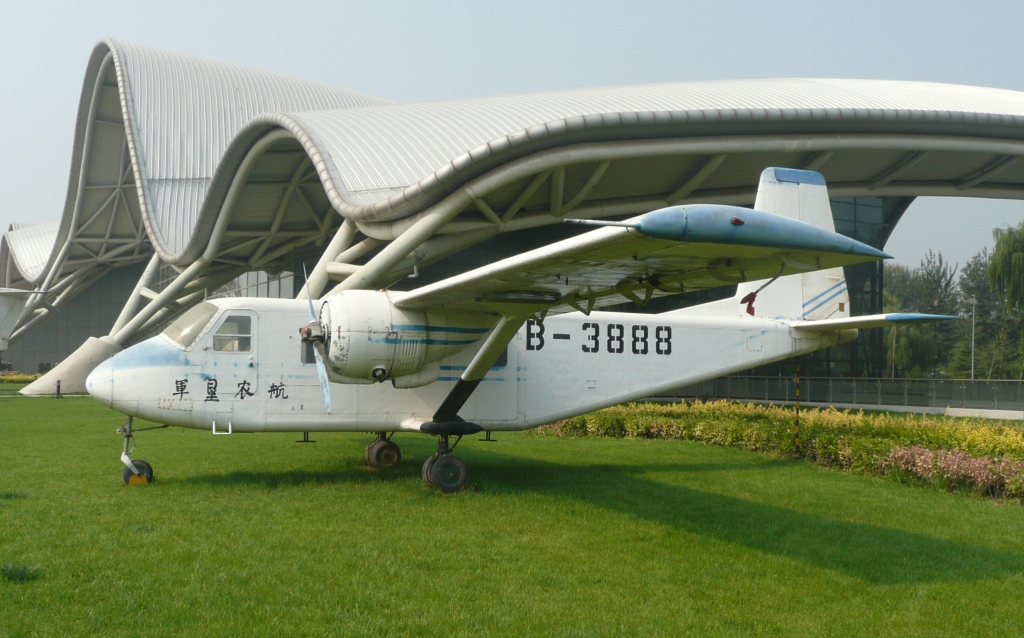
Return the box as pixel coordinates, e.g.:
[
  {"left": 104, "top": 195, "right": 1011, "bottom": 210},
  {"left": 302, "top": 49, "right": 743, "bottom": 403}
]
[{"left": 8, "top": 40, "right": 1024, "bottom": 344}]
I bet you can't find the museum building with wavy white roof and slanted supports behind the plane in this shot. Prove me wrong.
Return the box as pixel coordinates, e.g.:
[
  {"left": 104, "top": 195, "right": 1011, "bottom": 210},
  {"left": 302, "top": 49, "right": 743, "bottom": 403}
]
[{"left": 6, "top": 40, "right": 1024, "bottom": 393}]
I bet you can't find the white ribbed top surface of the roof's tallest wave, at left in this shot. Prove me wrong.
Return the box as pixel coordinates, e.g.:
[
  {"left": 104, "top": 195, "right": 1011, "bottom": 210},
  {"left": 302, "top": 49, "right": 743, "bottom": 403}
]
[{"left": 104, "top": 40, "right": 390, "bottom": 253}]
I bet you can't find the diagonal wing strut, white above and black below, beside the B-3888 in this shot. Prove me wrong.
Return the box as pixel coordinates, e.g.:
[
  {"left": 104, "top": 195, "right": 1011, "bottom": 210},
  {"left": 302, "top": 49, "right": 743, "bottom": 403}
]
[{"left": 420, "top": 314, "right": 527, "bottom": 434}]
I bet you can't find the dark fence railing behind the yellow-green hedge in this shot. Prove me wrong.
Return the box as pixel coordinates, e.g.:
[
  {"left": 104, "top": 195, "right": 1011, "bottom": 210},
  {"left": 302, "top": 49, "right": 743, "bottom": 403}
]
[{"left": 660, "top": 377, "right": 1024, "bottom": 410}]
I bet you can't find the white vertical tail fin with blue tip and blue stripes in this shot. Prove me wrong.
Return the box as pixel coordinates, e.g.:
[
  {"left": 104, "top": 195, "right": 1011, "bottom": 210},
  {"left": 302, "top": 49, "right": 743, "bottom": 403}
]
[{"left": 679, "top": 168, "right": 850, "bottom": 320}]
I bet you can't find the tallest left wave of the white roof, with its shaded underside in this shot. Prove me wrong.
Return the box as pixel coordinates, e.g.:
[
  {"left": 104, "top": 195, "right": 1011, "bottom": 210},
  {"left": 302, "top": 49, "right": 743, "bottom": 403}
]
[{"left": 32, "top": 40, "right": 390, "bottom": 282}]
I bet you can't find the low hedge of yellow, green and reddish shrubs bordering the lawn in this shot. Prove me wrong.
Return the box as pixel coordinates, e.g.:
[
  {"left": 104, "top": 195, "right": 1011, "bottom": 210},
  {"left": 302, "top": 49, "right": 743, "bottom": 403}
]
[{"left": 541, "top": 400, "right": 1024, "bottom": 499}]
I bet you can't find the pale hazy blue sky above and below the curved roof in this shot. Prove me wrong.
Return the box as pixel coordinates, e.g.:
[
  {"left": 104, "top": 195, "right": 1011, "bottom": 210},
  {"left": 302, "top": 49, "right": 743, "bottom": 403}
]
[{"left": 0, "top": 0, "right": 1024, "bottom": 265}]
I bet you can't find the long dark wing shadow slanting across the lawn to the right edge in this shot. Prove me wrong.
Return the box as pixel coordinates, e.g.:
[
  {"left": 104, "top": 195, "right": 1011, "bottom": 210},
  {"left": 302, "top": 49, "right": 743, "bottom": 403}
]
[{"left": 475, "top": 446, "right": 1024, "bottom": 585}]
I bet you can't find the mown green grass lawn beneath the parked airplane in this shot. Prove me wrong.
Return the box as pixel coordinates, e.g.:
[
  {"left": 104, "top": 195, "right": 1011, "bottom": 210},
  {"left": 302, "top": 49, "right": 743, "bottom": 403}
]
[{"left": 0, "top": 397, "right": 1024, "bottom": 637}]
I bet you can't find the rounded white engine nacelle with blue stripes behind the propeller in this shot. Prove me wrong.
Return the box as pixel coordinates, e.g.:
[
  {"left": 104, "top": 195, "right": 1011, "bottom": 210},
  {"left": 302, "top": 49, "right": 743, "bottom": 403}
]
[{"left": 319, "top": 290, "right": 498, "bottom": 387}]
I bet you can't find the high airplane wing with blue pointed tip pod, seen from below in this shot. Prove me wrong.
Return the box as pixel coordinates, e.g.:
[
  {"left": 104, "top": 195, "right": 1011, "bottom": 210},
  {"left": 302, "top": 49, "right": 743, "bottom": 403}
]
[{"left": 395, "top": 205, "right": 890, "bottom": 316}]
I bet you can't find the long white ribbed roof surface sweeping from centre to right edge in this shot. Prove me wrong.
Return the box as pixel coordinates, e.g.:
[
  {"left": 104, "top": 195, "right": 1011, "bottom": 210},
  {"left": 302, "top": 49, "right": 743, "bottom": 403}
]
[{"left": 260, "top": 79, "right": 1024, "bottom": 220}]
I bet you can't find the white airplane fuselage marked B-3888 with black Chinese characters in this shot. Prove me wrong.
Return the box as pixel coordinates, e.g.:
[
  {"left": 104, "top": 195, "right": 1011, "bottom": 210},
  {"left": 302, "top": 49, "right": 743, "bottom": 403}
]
[{"left": 87, "top": 298, "right": 849, "bottom": 432}]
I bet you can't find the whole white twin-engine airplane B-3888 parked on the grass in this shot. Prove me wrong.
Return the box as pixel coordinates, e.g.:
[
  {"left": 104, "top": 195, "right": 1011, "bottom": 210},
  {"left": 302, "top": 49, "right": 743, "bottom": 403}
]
[{"left": 86, "top": 168, "right": 940, "bottom": 492}]
